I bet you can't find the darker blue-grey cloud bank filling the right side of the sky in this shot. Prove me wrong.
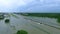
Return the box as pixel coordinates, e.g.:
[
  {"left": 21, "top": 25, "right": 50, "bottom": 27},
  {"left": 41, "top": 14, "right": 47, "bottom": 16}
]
[{"left": 22, "top": 0, "right": 60, "bottom": 13}]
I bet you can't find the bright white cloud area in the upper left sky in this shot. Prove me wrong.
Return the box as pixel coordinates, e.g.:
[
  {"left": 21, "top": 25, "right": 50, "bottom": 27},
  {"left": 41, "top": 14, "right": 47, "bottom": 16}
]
[{"left": 0, "top": 0, "right": 33, "bottom": 12}]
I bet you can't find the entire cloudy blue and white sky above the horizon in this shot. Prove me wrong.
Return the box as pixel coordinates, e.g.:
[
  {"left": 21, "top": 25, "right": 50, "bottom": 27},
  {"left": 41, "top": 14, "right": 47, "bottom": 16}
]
[{"left": 0, "top": 0, "right": 60, "bottom": 12}]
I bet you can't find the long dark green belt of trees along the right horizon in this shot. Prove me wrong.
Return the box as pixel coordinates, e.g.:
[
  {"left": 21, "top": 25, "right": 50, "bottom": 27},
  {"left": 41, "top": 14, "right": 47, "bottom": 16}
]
[{"left": 21, "top": 13, "right": 60, "bottom": 23}]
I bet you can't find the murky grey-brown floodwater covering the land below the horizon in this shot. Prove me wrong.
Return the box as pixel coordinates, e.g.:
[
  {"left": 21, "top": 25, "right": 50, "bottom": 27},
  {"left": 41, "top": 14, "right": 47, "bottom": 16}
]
[{"left": 0, "top": 14, "right": 60, "bottom": 34}]
